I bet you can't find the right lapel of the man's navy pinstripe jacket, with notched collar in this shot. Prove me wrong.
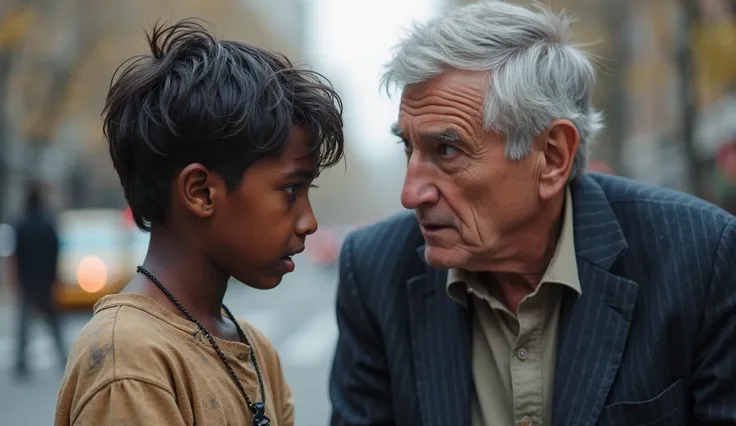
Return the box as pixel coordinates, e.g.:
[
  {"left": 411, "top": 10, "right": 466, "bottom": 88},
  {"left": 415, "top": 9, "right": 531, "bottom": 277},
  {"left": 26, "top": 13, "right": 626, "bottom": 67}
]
[{"left": 553, "top": 176, "right": 637, "bottom": 426}]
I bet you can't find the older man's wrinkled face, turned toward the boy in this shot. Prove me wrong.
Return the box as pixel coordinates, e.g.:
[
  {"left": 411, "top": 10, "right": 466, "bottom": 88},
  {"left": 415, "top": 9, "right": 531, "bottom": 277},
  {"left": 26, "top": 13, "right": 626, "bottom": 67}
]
[{"left": 395, "top": 71, "right": 544, "bottom": 269}]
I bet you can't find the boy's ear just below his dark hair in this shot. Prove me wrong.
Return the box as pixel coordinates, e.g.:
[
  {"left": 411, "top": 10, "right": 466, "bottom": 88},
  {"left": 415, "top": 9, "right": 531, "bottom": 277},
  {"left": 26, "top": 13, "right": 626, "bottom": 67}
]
[{"left": 177, "top": 163, "right": 223, "bottom": 219}]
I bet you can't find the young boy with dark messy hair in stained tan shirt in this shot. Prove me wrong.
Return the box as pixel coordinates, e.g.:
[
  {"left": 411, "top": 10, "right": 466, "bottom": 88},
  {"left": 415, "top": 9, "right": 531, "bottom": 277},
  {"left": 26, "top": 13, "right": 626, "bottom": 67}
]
[{"left": 55, "top": 20, "right": 343, "bottom": 426}]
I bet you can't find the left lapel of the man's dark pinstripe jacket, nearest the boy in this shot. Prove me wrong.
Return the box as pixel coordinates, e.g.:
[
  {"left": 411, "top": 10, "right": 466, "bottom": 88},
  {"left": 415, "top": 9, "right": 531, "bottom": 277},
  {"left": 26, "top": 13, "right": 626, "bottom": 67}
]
[{"left": 408, "top": 246, "right": 472, "bottom": 426}]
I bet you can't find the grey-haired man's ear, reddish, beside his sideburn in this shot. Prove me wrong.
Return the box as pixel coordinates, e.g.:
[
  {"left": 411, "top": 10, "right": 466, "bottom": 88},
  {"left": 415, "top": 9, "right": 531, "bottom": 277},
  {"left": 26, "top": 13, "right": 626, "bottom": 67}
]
[{"left": 539, "top": 120, "right": 580, "bottom": 200}]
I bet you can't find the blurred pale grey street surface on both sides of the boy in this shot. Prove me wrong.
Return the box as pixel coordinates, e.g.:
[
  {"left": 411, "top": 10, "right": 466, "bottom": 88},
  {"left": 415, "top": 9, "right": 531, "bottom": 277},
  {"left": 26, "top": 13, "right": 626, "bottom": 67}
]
[{"left": 0, "top": 258, "right": 337, "bottom": 426}]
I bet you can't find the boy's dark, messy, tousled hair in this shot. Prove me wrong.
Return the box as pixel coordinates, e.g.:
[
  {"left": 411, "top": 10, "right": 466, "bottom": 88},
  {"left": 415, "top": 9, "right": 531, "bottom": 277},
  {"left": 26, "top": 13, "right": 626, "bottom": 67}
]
[{"left": 102, "top": 19, "right": 343, "bottom": 231}]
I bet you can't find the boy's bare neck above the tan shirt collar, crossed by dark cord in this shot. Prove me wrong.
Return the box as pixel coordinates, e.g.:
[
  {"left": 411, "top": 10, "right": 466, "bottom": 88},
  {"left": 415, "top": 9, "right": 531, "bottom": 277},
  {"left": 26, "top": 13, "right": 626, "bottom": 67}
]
[{"left": 140, "top": 230, "right": 229, "bottom": 327}]
